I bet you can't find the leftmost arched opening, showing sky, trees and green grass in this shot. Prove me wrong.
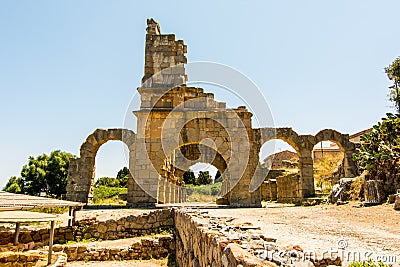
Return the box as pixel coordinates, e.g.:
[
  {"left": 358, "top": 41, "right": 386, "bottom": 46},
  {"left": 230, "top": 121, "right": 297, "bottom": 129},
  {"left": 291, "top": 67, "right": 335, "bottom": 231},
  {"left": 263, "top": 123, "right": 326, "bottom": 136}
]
[{"left": 91, "top": 140, "right": 130, "bottom": 205}]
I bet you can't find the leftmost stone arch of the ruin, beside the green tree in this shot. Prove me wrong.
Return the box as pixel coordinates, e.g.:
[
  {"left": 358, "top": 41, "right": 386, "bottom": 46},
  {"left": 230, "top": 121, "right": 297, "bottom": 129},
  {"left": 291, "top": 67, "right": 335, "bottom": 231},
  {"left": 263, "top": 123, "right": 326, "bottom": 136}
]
[{"left": 67, "top": 129, "right": 136, "bottom": 203}]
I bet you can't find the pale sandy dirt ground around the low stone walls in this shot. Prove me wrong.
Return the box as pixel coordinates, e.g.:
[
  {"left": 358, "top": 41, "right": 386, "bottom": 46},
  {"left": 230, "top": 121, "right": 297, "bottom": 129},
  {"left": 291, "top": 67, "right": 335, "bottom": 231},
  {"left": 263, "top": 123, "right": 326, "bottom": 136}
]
[{"left": 62, "top": 203, "right": 400, "bottom": 267}]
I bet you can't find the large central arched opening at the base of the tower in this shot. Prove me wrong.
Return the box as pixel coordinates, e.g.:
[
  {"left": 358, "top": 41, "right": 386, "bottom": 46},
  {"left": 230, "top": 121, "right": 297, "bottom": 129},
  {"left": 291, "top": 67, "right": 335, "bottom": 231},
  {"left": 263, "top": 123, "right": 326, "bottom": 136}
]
[{"left": 158, "top": 143, "right": 227, "bottom": 203}]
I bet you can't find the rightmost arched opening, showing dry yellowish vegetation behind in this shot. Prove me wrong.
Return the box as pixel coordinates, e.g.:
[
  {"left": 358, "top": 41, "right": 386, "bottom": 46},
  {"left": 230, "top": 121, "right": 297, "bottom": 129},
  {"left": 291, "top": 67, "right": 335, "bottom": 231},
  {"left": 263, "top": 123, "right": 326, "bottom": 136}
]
[{"left": 312, "top": 140, "right": 344, "bottom": 194}]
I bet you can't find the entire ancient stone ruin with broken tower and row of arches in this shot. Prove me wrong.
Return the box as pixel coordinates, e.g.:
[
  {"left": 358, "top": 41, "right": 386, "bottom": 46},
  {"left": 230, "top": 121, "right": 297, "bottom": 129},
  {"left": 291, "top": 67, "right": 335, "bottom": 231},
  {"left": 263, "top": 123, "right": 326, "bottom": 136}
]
[{"left": 67, "top": 19, "right": 356, "bottom": 207}]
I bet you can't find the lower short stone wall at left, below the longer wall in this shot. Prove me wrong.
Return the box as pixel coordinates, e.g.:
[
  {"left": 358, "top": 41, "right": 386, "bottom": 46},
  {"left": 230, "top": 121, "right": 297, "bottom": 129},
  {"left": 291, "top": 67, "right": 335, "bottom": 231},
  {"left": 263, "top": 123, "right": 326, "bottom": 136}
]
[{"left": 53, "top": 234, "right": 175, "bottom": 261}]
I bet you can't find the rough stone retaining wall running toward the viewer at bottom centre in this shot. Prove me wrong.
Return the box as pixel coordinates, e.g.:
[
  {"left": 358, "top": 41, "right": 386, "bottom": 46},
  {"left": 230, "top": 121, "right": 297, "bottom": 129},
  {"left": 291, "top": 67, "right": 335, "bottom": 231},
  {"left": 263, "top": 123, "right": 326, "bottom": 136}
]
[{"left": 175, "top": 210, "right": 276, "bottom": 267}]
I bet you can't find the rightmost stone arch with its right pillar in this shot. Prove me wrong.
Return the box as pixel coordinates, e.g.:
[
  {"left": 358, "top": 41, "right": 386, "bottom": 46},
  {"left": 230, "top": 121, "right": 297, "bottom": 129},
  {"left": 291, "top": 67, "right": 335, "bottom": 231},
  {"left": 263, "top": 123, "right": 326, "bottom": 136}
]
[{"left": 313, "top": 129, "right": 357, "bottom": 177}]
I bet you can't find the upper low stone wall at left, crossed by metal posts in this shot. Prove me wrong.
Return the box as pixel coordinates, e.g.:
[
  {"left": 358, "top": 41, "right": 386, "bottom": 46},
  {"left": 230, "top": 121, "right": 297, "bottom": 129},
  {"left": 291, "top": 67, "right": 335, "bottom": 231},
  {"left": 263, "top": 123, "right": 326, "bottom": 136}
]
[{"left": 0, "top": 209, "right": 174, "bottom": 245}]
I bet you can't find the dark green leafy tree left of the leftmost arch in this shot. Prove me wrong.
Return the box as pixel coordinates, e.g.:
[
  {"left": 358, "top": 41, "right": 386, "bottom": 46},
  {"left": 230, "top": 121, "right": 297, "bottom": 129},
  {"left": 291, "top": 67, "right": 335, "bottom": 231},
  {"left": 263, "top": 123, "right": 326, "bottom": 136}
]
[{"left": 4, "top": 150, "right": 75, "bottom": 198}]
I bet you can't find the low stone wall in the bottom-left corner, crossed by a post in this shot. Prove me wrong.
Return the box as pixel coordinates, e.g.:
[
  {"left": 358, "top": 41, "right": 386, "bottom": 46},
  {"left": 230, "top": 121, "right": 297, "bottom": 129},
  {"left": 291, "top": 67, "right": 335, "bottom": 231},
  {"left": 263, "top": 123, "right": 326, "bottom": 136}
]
[{"left": 0, "top": 251, "right": 67, "bottom": 267}]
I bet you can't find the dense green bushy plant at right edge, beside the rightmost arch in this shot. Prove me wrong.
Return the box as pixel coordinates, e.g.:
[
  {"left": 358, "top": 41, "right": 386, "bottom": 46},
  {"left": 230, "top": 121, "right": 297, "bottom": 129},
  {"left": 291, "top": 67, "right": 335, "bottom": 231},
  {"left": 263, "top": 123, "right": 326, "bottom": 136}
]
[{"left": 353, "top": 113, "right": 400, "bottom": 193}]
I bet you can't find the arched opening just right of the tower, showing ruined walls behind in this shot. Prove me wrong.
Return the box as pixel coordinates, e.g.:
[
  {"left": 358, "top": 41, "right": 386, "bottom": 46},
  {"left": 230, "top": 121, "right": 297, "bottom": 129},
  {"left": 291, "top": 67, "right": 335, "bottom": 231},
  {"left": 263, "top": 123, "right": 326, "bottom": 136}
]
[{"left": 259, "top": 139, "right": 301, "bottom": 201}]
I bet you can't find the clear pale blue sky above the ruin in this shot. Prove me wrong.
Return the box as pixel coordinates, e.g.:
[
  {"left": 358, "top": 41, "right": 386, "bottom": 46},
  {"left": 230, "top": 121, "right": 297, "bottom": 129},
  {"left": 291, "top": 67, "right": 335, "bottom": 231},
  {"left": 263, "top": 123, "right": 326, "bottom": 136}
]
[{"left": 0, "top": 0, "right": 400, "bottom": 186}]
